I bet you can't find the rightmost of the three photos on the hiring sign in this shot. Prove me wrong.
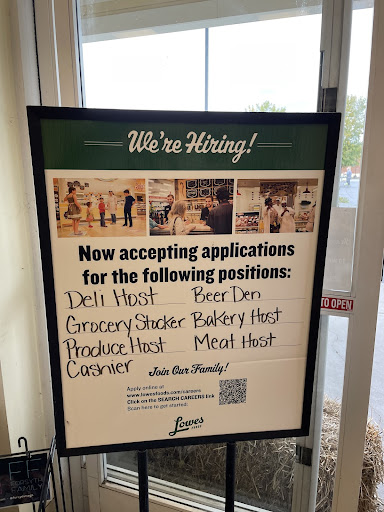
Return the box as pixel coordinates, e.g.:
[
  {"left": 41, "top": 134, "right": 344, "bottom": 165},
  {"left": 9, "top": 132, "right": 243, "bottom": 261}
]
[{"left": 236, "top": 179, "right": 318, "bottom": 234}]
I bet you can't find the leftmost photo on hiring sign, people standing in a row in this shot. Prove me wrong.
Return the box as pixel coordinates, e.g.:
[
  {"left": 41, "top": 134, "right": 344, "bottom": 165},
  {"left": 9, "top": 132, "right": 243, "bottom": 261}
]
[{"left": 53, "top": 178, "right": 146, "bottom": 238}]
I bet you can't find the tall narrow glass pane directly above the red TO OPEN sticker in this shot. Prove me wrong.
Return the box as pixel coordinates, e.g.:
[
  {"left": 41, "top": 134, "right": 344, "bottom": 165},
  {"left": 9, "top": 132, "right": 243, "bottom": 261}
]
[{"left": 324, "top": 8, "right": 373, "bottom": 292}]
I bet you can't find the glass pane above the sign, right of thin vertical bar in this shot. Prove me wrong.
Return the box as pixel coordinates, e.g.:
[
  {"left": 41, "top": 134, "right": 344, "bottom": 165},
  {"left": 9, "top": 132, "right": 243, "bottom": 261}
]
[{"left": 208, "top": 14, "right": 321, "bottom": 112}]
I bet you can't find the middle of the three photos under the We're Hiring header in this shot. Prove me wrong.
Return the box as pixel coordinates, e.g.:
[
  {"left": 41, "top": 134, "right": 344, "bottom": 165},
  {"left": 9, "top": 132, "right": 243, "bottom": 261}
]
[{"left": 148, "top": 178, "right": 234, "bottom": 236}]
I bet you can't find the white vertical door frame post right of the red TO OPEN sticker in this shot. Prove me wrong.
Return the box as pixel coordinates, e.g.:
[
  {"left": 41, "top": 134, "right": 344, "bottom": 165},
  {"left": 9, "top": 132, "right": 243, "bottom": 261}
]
[{"left": 332, "top": 1, "right": 384, "bottom": 512}]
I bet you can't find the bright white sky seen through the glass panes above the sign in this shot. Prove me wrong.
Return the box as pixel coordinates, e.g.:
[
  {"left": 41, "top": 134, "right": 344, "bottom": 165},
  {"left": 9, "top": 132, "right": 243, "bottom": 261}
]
[{"left": 83, "top": 9, "right": 373, "bottom": 112}]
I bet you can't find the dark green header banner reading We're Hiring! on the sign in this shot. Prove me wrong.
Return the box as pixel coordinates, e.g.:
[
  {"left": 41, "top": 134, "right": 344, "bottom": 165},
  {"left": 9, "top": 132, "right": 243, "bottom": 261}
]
[{"left": 41, "top": 113, "right": 328, "bottom": 170}]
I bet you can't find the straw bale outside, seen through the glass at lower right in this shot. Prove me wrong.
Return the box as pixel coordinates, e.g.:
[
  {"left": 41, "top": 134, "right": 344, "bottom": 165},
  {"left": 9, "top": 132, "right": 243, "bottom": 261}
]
[{"left": 149, "top": 397, "right": 384, "bottom": 512}]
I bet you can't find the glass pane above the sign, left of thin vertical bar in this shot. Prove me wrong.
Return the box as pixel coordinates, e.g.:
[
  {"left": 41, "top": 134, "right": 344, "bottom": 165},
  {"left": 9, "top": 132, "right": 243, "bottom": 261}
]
[{"left": 82, "top": 29, "right": 205, "bottom": 110}]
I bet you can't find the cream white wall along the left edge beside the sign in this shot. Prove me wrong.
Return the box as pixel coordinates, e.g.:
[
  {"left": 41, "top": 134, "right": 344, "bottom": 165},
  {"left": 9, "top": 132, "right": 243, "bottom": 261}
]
[{"left": 0, "top": 0, "right": 49, "bottom": 453}]
